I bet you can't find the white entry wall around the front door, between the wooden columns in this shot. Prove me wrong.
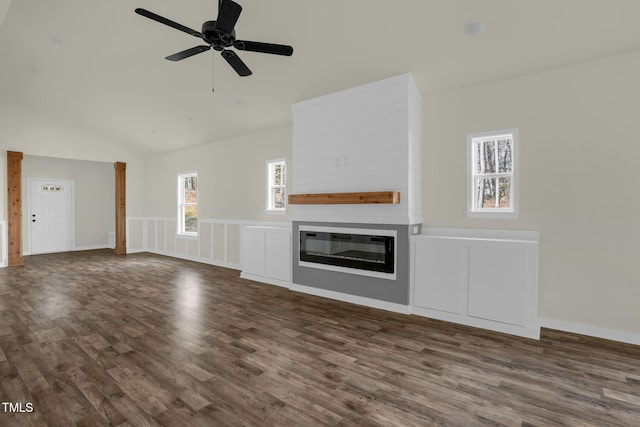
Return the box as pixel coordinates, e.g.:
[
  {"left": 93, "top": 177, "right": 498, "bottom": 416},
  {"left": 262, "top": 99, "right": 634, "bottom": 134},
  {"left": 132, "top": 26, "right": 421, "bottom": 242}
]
[{"left": 22, "top": 155, "right": 115, "bottom": 254}]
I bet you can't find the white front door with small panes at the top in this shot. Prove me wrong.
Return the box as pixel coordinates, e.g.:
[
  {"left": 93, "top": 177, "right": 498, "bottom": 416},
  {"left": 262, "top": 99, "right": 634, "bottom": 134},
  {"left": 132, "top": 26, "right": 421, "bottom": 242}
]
[{"left": 26, "top": 178, "right": 73, "bottom": 254}]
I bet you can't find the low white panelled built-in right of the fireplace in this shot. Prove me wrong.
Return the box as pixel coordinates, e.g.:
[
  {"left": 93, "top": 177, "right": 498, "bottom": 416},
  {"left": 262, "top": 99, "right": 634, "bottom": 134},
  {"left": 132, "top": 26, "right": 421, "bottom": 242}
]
[{"left": 411, "top": 228, "right": 540, "bottom": 339}]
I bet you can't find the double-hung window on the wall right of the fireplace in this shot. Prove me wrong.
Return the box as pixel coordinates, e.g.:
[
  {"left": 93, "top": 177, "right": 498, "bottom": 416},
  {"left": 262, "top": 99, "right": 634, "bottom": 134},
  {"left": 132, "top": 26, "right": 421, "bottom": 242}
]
[{"left": 467, "top": 129, "right": 518, "bottom": 218}]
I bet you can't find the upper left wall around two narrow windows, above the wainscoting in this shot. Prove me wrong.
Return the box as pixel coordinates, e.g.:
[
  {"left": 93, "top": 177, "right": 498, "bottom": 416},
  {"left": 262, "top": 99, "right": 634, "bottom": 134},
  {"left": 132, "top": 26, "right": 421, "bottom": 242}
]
[{"left": 145, "top": 127, "right": 292, "bottom": 221}]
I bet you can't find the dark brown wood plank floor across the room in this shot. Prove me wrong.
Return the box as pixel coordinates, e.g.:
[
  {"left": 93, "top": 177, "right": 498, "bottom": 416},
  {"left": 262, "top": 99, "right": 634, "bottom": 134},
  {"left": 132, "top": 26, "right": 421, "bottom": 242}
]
[{"left": 0, "top": 251, "right": 640, "bottom": 427}]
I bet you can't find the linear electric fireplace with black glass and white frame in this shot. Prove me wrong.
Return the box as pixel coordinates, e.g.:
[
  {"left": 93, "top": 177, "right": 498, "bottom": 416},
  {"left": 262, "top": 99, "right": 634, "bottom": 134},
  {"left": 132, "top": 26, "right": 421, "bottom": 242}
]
[{"left": 299, "top": 225, "right": 397, "bottom": 279}]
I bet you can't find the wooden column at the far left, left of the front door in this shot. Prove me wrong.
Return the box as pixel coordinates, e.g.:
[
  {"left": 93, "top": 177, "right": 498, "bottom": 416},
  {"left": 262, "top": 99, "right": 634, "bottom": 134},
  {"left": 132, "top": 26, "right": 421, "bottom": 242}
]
[{"left": 7, "top": 151, "right": 24, "bottom": 266}]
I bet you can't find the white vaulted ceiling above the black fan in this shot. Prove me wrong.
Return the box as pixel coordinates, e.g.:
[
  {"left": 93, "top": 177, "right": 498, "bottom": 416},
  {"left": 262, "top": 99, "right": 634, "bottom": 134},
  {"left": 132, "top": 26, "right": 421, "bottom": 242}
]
[{"left": 0, "top": 0, "right": 640, "bottom": 155}]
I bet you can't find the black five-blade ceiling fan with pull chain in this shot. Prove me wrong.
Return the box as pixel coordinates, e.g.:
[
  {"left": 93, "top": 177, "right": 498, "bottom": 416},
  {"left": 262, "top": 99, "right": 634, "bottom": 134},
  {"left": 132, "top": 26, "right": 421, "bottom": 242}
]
[{"left": 135, "top": 0, "right": 293, "bottom": 77}]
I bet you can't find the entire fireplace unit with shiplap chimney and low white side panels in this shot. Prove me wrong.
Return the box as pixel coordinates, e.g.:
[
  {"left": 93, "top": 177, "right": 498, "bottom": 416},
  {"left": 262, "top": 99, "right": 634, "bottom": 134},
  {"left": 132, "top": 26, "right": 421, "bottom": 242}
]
[{"left": 241, "top": 74, "right": 540, "bottom": 338}]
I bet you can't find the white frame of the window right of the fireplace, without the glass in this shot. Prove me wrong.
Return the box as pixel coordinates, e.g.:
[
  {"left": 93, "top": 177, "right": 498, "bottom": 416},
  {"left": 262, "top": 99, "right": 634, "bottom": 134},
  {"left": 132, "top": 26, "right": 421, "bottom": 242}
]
[{"left": 466, "top": 129, "right": 520, "bottom": 219}]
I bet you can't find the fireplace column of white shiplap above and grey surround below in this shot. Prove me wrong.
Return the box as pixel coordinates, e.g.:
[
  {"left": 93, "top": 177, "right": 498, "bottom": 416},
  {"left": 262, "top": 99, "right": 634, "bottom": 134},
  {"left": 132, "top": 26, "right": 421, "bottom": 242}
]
[{"left": 292, "top": 74, "right": 422, "bottom": 312}]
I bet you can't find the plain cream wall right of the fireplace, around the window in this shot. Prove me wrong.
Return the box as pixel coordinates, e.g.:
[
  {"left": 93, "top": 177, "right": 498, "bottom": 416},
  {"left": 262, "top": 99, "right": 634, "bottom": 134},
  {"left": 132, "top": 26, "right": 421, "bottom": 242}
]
[{"left": 423, "top": 52, "right": 640, "bottom": 334}]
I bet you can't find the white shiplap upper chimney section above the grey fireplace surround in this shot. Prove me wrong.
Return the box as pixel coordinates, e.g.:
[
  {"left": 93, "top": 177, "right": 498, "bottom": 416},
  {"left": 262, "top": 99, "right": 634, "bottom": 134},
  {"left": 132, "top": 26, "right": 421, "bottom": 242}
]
[{"left": 292, "top": 74, "right": 422, "bottom": 225}]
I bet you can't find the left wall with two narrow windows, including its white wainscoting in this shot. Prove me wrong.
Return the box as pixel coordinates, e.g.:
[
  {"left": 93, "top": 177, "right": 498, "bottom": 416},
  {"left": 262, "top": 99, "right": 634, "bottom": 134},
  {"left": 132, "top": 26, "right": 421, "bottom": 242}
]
[{"left": 141, "top": 127, "right": 292, "bottom": 269}]
